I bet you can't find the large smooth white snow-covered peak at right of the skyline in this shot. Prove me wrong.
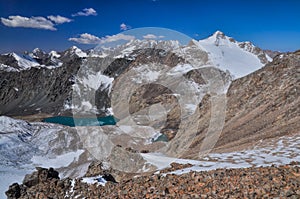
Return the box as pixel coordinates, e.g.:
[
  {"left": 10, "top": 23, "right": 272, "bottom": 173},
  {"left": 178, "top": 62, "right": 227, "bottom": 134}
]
[{"left": 198, "top": 31, "right": 272, "bottom": 78}]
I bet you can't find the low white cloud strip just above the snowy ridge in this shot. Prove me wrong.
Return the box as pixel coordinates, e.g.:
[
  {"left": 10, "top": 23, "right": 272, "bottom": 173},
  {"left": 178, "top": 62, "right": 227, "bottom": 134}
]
[{"left": 69, "top": 33, "right": 135, "bottom": 44}]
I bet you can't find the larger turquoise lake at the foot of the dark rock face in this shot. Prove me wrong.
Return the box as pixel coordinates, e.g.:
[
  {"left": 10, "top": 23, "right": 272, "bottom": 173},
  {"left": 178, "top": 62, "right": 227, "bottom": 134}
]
[{"left": 43, "top": 116, "right": 117, "bottom": 127}]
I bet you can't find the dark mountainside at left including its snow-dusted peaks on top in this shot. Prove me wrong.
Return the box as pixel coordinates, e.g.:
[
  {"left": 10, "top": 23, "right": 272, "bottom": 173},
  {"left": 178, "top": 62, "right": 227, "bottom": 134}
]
[{"left": 0, "top": 47, "right": 82, "bottom": 116}]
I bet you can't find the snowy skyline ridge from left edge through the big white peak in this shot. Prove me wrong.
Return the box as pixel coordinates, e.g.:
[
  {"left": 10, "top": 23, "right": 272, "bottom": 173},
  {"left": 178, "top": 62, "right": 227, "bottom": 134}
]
[{"left": 0, "top": 31, "right": 272, "bottom": 78}]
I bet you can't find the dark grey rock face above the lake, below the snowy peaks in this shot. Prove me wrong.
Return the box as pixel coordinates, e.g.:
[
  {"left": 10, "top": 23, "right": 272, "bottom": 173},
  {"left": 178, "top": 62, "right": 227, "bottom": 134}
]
[{"left": 0, "top": 59, "right": 81, "bottom": 116}]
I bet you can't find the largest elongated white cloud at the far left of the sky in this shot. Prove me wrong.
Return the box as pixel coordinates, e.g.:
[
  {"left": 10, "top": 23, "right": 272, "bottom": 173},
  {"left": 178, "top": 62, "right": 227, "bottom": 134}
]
[{"left": 1, "top": 15, "right": 56, "bottom": 30}]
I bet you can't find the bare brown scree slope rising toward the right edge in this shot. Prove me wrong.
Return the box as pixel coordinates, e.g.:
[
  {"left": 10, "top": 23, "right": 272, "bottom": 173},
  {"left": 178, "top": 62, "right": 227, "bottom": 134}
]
[{"left": 167, "top": 51, "right": 300, "bottom": 159}]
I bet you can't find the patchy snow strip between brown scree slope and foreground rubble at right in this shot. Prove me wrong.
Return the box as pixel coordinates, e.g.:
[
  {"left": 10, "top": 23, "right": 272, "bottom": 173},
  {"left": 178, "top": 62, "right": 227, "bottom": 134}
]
[{"left": 141, "top": 135, "right": 300, "bottom": 175}]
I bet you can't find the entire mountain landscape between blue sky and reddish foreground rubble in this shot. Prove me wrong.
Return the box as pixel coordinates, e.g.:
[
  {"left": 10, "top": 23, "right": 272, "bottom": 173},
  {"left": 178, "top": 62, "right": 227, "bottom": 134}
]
[{"left": 0, "top": 31, "right": 300, "bottom": 198}]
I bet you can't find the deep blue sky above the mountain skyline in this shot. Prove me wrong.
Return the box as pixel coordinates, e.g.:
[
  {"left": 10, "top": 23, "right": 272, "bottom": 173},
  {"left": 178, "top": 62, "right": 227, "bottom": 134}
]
[{"left": 0, "top": 0, "right": 300, "bottom": 53}]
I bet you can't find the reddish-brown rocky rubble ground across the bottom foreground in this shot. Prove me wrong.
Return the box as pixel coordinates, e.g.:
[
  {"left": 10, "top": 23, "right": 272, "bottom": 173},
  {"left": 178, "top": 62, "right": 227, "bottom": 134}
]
[{"left": 6, "top": 162, "right": 300, "bottom": 199}]
